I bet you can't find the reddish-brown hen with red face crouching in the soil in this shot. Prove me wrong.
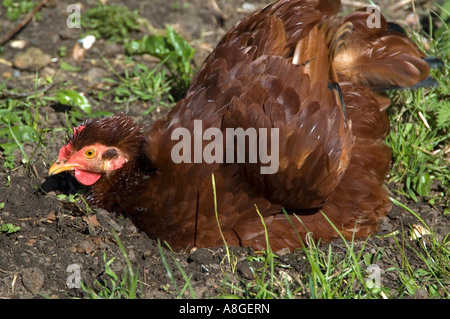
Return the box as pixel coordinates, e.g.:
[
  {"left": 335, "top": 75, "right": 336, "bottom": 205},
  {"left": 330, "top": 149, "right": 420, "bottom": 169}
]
[{"left": 49, "top": 0, "right": 436, "bottom": 251}]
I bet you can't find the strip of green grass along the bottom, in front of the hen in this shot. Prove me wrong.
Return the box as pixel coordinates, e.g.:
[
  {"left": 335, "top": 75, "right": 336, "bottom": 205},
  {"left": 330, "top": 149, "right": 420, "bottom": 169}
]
[{"left": 153, "top": 202, "right": 450, "bottom": 299}]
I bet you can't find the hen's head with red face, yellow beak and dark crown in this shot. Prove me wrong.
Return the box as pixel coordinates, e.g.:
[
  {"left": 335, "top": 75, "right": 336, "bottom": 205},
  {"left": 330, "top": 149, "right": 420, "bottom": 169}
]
[{"left": 49, "top": 114, "right": 144, "bottom": 186}]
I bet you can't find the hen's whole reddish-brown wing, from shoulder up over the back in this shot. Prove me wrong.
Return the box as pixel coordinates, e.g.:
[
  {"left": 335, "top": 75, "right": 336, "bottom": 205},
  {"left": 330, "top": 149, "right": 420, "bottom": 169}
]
[{"left": 149, "top": 1, "right": 352, "bottom": 209}]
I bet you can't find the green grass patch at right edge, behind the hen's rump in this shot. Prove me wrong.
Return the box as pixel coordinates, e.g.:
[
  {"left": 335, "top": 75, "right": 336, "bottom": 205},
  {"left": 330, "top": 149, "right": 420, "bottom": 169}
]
[{"left": 386, "top": 13, "right": 450, "bottom": 205}]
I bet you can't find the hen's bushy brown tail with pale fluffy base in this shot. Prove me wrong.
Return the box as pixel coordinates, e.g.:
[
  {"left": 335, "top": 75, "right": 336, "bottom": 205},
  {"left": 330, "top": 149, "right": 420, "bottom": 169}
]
[{"left": 333, "top": 9, "right": 442, "bottom": 90}]
